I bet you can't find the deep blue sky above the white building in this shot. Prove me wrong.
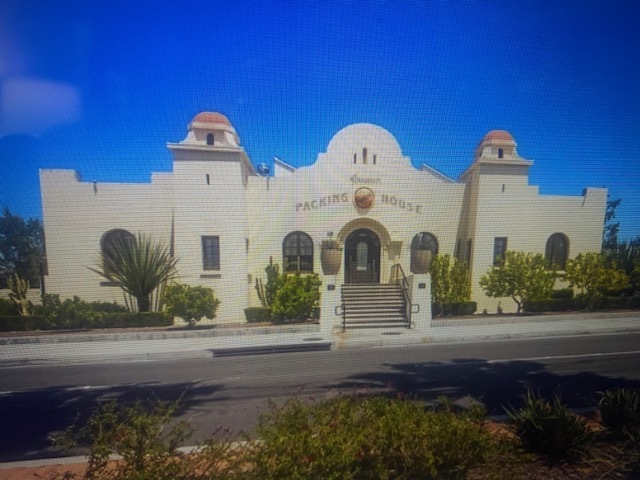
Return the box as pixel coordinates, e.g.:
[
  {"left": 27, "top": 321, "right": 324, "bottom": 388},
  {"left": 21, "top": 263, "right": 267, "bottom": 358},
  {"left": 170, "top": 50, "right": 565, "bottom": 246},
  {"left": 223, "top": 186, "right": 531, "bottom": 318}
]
[{"left": 0, "top": 0, "right": 640, "bottom": 237}]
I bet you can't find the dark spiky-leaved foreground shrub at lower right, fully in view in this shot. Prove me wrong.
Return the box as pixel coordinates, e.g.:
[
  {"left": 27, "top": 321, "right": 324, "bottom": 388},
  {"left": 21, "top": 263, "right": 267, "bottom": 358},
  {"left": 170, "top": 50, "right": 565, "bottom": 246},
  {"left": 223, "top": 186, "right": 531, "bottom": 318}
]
[{"left": 507, "top": 391, "right": 595, "bottom": 459}]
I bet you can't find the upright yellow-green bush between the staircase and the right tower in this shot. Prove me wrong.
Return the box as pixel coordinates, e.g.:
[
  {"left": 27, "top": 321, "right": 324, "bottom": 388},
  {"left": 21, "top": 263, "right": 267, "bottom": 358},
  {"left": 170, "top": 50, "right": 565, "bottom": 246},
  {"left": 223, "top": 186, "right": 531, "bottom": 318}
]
[{"left": 431, "top": 255, "right": 471, "bottom": 313}]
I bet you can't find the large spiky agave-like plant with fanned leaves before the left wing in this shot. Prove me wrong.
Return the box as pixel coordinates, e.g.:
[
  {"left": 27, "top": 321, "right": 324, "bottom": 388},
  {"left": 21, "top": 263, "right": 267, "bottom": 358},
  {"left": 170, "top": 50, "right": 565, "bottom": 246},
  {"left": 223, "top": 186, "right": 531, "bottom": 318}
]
[{"left": 89, "top": 233, "right": 178, "bottom": 312}]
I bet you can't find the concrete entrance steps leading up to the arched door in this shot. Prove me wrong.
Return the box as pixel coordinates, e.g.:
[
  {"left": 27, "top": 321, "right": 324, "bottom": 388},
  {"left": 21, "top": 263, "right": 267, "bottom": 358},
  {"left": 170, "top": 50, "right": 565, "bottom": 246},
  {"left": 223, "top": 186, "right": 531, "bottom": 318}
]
[{"left": 342, "top": 283, "right": 409, "bottom": 328}]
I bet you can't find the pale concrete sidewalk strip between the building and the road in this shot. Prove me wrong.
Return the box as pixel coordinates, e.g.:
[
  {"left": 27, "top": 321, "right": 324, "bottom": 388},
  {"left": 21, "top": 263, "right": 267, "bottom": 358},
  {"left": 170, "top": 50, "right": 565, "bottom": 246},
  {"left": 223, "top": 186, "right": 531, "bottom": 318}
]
[{"left": 0, "top": 311, "right": 640, "bottom": 367}]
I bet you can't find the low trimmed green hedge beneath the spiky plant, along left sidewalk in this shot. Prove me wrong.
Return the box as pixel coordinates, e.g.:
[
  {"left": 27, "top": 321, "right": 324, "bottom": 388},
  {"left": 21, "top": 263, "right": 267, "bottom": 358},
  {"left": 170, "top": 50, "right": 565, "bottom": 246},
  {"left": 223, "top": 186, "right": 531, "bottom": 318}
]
[{"left": 0, "top": 312, "right": 173, "bottom": 332}]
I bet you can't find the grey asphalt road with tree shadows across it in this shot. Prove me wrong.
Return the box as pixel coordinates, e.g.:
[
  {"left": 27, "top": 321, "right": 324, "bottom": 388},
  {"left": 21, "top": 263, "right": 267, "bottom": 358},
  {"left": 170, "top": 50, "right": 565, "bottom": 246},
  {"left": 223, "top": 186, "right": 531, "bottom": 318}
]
[{"left": 0, "top": 334, "right": 640, "bottom": 462}]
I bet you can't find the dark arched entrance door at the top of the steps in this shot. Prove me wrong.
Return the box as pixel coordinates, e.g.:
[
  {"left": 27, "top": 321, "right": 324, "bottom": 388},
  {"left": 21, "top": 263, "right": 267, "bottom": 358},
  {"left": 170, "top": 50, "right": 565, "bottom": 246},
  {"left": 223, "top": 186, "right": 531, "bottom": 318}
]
[{"left": 344, "top": 228, "right": 380, "bottom": 283}]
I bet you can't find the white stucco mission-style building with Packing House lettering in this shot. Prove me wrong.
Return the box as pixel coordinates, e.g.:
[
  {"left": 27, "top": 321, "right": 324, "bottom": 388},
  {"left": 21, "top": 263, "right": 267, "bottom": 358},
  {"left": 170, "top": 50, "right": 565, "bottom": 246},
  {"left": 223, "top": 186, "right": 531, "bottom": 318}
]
[{"left": 40, "top": 112, "right": 607, "bottom": 330}]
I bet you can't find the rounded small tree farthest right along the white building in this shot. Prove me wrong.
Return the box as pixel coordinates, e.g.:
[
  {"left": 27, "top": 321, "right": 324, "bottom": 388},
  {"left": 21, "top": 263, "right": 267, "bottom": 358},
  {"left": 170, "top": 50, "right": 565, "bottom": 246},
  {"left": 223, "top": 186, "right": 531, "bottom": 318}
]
[{"left": 564, "top": 253, "right": 629, "bottom": 309}]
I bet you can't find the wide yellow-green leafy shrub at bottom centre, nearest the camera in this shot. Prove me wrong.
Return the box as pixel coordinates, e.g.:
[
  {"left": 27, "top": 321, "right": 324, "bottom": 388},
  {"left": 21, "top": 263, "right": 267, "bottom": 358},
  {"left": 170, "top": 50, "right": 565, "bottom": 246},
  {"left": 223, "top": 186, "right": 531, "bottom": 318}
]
[{"left": 253, "top": 397, "right": 492, "bottom": 480}]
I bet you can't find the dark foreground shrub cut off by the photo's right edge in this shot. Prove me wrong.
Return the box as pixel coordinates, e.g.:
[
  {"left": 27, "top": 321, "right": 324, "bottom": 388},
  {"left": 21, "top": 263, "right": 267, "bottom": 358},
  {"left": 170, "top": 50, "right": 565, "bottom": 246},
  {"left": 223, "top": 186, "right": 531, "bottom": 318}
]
[{"left": 599, "top": 388, "right": 640, "bottom": 442}]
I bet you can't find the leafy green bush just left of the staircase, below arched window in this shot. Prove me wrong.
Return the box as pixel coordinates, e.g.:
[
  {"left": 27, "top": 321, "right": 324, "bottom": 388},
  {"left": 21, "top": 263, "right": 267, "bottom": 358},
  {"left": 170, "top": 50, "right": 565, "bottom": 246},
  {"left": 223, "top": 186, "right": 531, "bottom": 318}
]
[{"left": 271, "top": 272, "right": 321, "bottom": 322}]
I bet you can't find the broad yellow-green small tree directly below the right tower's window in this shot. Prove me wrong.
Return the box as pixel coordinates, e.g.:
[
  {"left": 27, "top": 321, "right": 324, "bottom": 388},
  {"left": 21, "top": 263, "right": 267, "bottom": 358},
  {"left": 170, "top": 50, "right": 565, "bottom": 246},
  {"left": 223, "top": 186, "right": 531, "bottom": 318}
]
[{"left": 480, "top": 251, "right": 557, "bottom": 313}]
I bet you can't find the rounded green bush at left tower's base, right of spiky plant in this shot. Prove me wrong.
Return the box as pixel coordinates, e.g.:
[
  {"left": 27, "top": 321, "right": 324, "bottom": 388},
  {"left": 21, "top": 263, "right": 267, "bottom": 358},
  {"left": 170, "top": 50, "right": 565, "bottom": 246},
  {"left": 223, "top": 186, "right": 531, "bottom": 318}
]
[{"left": 163, "top": 284, "right": 220, "bottom": 327}]
